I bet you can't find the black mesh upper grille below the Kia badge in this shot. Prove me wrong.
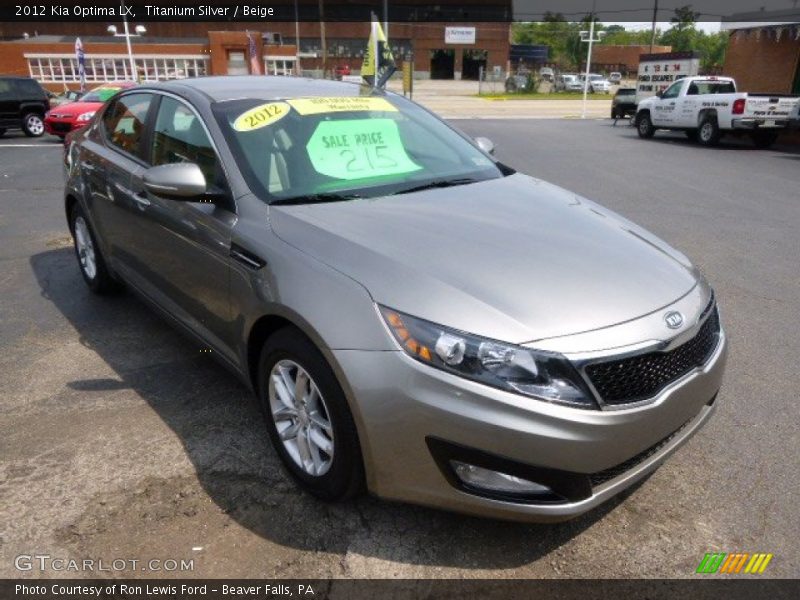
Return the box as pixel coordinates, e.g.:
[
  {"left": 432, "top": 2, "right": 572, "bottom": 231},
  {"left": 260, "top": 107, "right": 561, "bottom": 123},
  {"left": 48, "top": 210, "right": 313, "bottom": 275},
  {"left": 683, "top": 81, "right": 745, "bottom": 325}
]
[{"left": 585, "top": 299, "right": 719, "bottom": 405}]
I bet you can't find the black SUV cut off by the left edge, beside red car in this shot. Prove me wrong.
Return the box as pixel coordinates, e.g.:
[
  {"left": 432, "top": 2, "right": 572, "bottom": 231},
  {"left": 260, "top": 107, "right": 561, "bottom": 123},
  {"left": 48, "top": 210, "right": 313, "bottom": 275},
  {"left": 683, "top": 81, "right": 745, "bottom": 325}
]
[{"left": 0, "top": 76, "right": 50, "bottom": 137}]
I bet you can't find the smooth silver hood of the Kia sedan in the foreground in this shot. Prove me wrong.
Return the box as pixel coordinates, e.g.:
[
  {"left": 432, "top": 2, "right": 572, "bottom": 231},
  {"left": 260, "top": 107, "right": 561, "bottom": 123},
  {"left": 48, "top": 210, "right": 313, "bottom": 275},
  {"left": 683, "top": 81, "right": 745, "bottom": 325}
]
[{"left": 270, "top": 174, "right": 699, "bottom": 343}]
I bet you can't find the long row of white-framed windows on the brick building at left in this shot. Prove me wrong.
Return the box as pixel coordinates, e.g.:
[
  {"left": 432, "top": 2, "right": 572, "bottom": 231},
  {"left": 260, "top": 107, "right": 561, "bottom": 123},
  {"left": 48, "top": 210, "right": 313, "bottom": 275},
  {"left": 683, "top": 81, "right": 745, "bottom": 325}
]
[{"left": 25, "top": 54, "right": 208, "bottom": 83}]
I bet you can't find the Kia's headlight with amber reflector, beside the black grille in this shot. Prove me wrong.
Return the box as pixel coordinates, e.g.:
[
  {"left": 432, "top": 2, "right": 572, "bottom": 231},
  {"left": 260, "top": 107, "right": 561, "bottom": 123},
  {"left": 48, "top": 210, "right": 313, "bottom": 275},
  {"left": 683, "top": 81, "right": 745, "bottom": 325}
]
[{"left": 379, "top": 306, "right": 598, "bottom": 409}]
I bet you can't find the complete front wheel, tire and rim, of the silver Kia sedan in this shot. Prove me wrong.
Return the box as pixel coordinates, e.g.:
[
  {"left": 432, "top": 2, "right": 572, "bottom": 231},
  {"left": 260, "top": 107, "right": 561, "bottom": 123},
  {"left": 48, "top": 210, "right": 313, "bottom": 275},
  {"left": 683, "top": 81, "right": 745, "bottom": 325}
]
[{"left": 258, "top": 327, "right": 364, "bottom": 502}]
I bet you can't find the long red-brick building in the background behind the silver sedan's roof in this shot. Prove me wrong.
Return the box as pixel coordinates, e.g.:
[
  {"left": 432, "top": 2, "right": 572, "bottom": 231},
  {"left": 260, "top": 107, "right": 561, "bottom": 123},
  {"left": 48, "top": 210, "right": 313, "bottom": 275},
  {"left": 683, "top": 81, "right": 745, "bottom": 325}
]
[{"left": 0, "top": 0, "right": 511, "bottom": 89}]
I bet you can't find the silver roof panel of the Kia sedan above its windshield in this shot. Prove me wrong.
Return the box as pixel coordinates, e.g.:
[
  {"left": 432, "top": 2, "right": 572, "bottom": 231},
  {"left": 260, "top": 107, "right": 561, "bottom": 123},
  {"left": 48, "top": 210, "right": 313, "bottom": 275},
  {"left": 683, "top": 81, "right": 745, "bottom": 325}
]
[{"left": 150, "top": 75, "right": 362, "bottom": 102}]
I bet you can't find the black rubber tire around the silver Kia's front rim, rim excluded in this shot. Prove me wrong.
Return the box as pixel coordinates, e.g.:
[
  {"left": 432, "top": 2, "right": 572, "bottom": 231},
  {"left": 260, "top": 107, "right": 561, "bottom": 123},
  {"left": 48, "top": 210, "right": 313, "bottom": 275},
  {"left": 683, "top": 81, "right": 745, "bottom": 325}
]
[{"left": 257, "top": 327, "right": 363, "bottom": 501}]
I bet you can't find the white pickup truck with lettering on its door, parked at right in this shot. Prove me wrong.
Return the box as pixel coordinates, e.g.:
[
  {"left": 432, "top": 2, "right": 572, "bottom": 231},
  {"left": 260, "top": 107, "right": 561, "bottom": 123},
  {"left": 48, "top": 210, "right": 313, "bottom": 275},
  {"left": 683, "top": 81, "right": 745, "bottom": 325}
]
[{"left": 635, "top": 76, "right": 800, "bottom": 148}]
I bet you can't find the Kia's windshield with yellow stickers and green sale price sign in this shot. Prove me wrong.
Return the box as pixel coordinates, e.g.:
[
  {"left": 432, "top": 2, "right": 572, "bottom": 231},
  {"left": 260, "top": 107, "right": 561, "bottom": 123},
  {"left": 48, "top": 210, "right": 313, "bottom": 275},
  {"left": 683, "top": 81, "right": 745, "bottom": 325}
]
[{"left": 212, "top": 95, "right": 507, "bottom": 203}]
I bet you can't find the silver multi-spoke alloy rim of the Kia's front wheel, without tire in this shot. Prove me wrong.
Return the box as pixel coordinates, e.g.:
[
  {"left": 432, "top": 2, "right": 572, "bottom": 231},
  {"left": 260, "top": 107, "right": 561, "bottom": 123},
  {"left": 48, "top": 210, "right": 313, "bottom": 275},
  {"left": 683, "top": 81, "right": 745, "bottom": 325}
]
[{"left": 269, "top": 359, "right": 334, "bottom": 477}]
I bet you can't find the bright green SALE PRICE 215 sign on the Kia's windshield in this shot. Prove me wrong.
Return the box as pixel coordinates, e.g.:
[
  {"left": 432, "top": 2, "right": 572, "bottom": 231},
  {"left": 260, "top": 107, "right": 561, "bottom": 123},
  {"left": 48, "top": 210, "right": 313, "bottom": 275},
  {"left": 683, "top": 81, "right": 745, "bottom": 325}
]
[{"left": 306, "top": 119, "right": 422, "bottom": 179}]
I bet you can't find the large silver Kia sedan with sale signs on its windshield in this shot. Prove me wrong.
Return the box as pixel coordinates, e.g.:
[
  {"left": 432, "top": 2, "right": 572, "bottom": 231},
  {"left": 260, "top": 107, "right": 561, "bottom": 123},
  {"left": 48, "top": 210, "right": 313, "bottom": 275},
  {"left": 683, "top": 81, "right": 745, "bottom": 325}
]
[{"left": 65, "top": 77, "right": 726, "bottom": 520}]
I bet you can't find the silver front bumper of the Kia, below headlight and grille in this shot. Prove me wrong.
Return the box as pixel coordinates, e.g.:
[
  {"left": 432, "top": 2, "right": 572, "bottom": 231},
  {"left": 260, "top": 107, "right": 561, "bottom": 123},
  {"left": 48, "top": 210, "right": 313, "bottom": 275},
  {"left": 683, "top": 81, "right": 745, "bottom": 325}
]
[{"left": 334, "top": 332, "right": 727, "bottom": 521}]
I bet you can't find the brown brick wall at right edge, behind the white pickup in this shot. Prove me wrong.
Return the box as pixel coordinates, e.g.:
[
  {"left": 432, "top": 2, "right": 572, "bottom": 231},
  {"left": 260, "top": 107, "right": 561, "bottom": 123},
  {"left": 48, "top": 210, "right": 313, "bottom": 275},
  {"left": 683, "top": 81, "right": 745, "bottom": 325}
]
[{"left": 723, "top": 30, "right": 800, "bottom": 94}]
